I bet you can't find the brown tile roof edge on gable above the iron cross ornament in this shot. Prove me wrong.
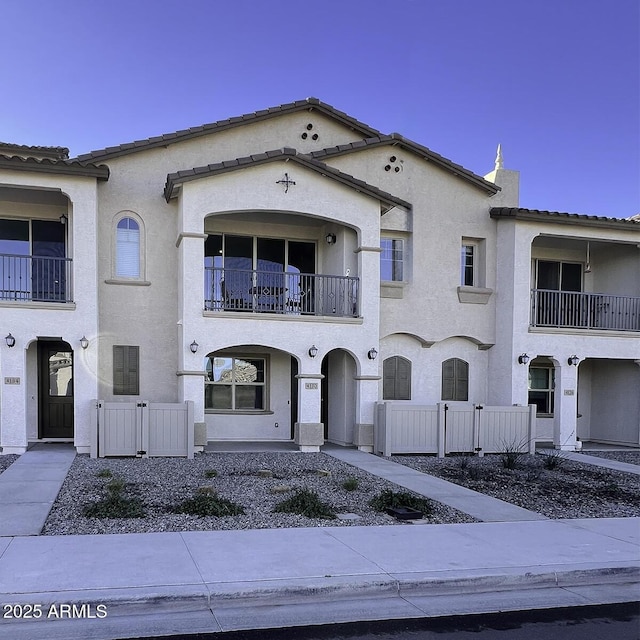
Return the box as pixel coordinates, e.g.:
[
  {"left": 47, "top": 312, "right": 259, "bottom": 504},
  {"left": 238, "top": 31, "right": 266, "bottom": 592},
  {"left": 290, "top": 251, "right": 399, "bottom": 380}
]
[{"left": 164, "top": 147, "right": 411, "bottom": 211}]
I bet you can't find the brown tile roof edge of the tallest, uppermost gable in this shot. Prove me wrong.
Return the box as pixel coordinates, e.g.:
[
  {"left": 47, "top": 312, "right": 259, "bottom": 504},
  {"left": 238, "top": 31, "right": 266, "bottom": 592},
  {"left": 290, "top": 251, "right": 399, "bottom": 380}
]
[{"left": 76, "top": 98, "right": 380, "bottom": 161}]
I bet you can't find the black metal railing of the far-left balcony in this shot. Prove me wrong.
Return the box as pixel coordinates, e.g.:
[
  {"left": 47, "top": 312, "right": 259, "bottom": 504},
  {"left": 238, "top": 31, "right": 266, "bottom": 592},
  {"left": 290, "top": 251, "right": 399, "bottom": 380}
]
[{"left": 0, "top": 254, "right": 72, "bottom": 302}]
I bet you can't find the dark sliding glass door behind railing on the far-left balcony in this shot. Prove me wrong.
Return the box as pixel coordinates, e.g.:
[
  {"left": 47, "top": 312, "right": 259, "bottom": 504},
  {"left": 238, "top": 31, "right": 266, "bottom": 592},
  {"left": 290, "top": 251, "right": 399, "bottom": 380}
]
[{"left": 0, "top": 219, "right": 71, "bottom": 302}]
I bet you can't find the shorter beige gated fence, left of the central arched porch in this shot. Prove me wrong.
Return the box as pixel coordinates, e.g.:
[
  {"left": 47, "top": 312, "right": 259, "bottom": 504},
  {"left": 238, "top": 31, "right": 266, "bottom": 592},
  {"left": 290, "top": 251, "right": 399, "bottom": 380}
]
[{"left": 91, "top": 400, "right": 194, "bottom": 458}]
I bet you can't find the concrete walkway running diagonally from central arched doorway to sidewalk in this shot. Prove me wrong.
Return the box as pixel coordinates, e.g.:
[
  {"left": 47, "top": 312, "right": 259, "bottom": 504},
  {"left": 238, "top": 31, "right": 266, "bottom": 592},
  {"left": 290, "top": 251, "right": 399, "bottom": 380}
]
[{"left": 323, "top": 445, "right": 547, "bottom": 522}]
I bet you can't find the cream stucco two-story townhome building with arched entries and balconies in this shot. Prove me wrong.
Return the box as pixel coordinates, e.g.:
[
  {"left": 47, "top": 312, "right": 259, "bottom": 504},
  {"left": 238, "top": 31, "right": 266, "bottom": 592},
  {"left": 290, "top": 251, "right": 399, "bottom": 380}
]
[{"left": 0, "top": 98, "right": 640, "bottom": 454}]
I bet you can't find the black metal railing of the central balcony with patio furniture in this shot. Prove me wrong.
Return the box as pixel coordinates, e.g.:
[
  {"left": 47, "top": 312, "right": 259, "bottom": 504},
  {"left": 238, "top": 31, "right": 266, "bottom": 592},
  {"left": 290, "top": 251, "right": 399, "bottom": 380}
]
[{"left": 204, "top": 267, "right": 358, "bottom": 318}]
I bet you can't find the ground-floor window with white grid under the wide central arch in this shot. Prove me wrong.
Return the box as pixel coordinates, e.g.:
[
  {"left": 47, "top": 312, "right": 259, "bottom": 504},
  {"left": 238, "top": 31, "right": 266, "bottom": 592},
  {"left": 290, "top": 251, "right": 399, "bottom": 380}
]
[{"left": 204, "top": 354, "right": 267, "bottom": 413}]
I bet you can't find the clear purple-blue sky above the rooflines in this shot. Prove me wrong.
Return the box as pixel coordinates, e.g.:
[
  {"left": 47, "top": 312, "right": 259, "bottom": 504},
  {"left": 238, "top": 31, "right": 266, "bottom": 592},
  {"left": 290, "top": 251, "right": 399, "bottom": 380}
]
[{"left": 0, "top": 0, "right": 640, "bottom": 217}]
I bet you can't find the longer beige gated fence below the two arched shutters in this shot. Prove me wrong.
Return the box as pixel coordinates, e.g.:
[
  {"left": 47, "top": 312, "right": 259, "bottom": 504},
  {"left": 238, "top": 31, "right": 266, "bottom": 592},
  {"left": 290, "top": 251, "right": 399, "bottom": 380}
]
[{"left": 374, "top": 402, "right": 536, "bottom": 457}]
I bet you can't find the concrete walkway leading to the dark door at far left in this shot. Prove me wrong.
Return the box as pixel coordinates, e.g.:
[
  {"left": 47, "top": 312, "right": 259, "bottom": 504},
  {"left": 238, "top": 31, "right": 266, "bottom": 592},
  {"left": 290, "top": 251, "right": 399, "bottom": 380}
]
[{"left": 0, "top": 443, "right": 76, "bottom": 536}]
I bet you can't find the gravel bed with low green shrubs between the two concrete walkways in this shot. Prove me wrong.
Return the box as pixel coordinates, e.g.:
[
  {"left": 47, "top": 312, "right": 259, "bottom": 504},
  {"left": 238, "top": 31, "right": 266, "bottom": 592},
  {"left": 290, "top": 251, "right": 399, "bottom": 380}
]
[{"left": 42, "top": 452, "right": 475, "bottom": 535}]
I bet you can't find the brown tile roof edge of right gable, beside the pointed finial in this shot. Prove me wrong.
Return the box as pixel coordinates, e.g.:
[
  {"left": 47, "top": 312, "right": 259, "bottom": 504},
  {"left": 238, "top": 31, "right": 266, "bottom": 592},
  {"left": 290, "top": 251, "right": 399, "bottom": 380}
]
[{"left": 311, "top": 133, "right": 500, "bottom": 195}]
